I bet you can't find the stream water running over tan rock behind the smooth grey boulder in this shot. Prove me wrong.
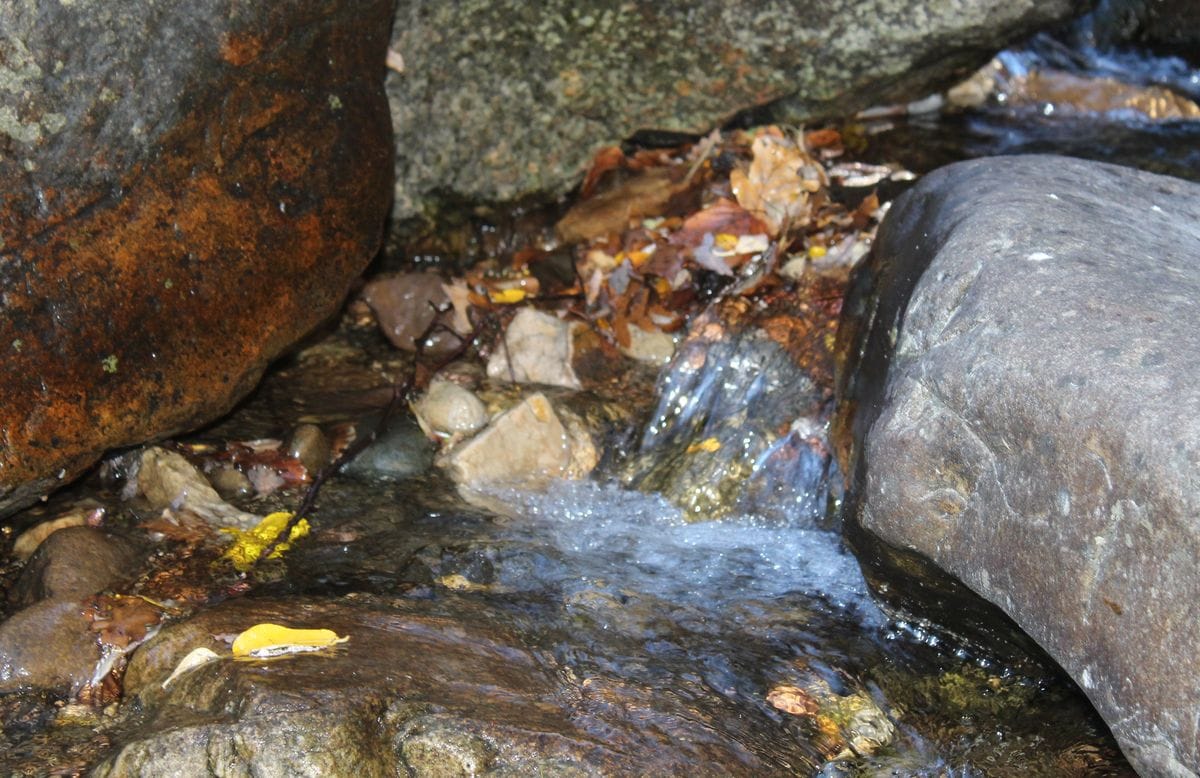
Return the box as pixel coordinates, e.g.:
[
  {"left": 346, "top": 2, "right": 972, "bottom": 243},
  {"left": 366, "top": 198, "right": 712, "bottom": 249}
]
[{"left": 863, "top": 17, "right": 1200, "bottom": 180}]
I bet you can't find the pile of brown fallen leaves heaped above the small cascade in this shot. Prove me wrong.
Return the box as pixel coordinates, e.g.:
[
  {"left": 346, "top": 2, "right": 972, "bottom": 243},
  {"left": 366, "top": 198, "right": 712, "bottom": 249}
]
[{"left": 448, "top": 126, "right": 913, "bottom": 349}]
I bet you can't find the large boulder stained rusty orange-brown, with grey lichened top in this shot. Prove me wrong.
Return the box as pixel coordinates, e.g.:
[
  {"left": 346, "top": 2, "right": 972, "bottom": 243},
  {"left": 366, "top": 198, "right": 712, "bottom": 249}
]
[{"left": 0, "top": 0, "right": 392, "bottom": 516}]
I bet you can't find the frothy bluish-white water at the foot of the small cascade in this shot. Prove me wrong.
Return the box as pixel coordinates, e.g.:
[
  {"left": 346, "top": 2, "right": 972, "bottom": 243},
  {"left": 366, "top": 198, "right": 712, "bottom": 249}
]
[{"left": 477, "top": 481, "right": 884, "bottom": 626}]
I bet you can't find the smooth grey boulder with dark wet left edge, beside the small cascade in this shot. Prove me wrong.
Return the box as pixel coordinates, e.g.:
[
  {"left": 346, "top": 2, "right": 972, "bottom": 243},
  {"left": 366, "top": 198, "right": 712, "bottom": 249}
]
[{"left": 844, "top": 156, "right": 1200, "bottom": 776}]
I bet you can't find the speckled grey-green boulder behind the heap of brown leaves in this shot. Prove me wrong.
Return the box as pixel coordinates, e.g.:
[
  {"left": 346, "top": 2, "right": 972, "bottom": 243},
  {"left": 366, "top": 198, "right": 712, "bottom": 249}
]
[{"left": 388, "top": 0, "right": 1084, "bottom": 221}]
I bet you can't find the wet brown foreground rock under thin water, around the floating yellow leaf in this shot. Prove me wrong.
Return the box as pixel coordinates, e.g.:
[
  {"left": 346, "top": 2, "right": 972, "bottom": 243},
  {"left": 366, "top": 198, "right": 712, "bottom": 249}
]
[{"left": 96, "top": 594, "right": 820, "bottom": 776}]
